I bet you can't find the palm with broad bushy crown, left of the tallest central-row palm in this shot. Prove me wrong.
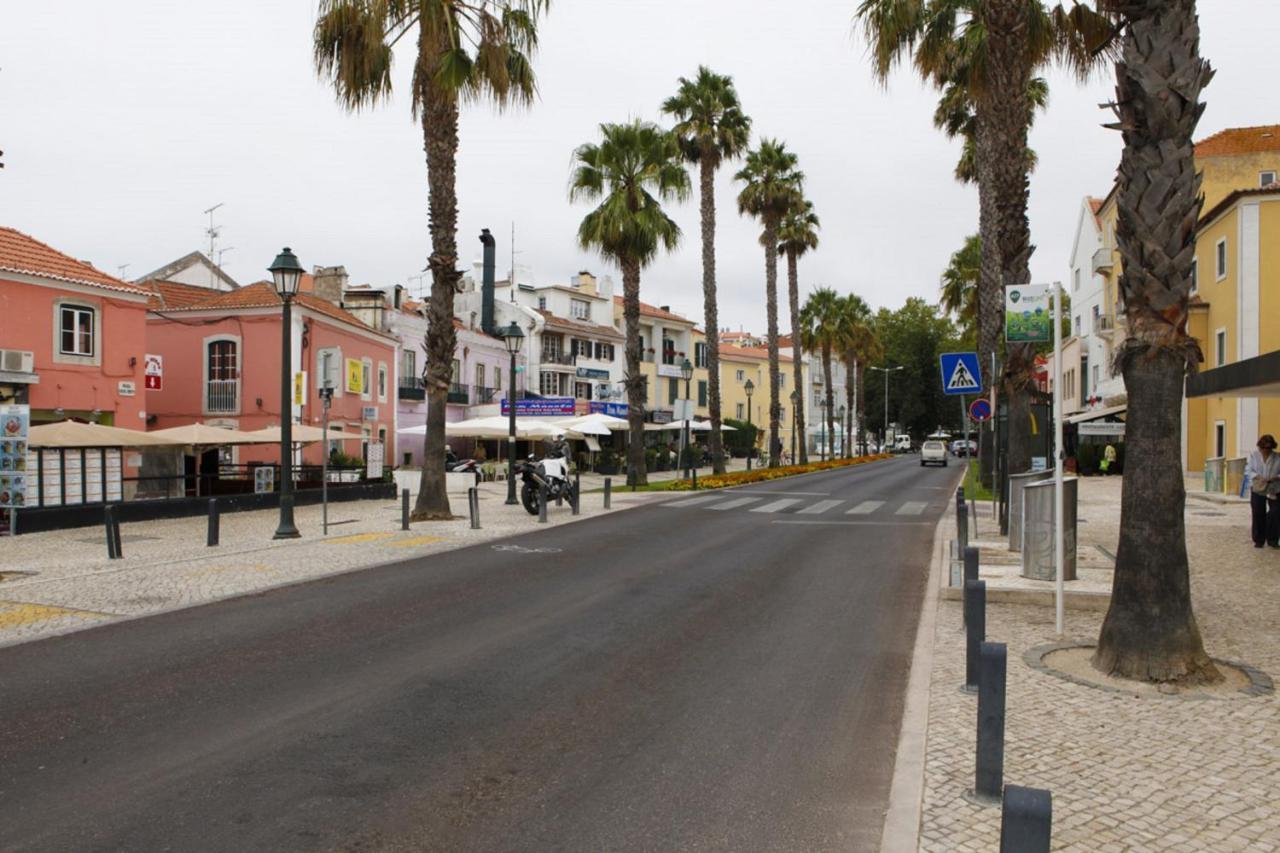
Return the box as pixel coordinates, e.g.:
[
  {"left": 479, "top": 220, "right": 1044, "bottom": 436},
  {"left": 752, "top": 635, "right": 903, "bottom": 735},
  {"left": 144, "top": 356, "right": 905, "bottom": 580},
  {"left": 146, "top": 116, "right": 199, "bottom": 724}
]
[{"left": 568, "top": 119, "right": 689, "bottom": 485}]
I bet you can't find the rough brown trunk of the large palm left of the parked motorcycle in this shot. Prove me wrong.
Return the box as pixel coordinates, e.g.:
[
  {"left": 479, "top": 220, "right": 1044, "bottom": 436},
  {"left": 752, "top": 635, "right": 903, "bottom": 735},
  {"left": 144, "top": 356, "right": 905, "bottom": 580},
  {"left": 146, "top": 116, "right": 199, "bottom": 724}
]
[{"left": 411, "top": 38, "right": 458, "bottom": 521}]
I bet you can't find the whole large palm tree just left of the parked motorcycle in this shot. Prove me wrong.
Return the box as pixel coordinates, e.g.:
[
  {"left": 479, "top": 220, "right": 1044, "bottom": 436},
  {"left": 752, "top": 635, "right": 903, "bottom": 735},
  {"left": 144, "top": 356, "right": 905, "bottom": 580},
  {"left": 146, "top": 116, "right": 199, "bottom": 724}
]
[{"left": 312, "top": 0, "right": 549, "bottom": 521}]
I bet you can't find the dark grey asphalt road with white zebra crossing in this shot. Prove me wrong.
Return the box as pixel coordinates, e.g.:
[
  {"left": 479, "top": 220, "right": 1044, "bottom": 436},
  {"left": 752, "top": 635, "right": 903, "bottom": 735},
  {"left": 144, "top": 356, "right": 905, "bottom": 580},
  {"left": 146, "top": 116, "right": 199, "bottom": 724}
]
[{"left": 0, "top": 456, "right": 957, "bottom": 852}]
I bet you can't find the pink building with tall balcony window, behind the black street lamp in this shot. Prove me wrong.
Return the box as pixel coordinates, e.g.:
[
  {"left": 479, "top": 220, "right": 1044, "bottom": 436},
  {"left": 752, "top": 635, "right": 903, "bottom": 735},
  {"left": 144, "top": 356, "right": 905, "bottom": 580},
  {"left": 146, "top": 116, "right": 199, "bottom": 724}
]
[{"left": 147, "top": 275, "right": 396, "bottom": 467}]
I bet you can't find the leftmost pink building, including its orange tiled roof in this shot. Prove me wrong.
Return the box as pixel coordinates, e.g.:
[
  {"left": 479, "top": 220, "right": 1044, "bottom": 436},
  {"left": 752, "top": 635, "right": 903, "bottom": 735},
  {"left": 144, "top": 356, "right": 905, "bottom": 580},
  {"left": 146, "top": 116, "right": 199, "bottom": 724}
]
[{"left": 0, "top": 228, "right": 148, "bottom": 429}]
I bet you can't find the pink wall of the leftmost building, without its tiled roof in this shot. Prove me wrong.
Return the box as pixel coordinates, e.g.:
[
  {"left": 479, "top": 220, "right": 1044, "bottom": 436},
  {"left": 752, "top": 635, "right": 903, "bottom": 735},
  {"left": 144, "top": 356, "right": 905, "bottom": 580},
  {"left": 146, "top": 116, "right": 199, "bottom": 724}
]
[{"left": 0, "top": 278, "right": 146, "bottom": 429}]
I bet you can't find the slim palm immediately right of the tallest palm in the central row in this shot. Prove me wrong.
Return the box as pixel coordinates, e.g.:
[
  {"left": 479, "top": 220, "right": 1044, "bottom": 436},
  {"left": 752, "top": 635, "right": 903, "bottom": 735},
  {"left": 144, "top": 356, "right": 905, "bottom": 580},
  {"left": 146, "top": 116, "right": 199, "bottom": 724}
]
[{"left": 733, "top": 140, "right": 804, "bottom": 467}]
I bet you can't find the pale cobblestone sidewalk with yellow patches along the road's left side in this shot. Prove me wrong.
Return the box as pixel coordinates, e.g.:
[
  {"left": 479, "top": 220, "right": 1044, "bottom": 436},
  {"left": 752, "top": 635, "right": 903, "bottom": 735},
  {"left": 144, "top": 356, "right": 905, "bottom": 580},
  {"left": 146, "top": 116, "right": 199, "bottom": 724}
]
[{"left": 0, "top": 483, "right": 671, "bottom": 646}]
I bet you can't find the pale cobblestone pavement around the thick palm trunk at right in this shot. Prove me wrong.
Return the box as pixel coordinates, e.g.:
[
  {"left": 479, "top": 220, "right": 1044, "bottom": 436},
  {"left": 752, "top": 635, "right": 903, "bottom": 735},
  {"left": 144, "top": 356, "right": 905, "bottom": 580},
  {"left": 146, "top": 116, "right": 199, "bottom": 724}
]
[{"left": 918, "top": 478, "right": 1280, "bottom": 853}]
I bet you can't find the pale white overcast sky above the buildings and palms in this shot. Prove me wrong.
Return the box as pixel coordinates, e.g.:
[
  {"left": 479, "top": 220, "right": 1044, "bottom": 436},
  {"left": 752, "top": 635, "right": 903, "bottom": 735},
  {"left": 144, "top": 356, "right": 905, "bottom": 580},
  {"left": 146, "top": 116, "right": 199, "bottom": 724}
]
[{"left": 0, "top": 0, "right": 1280, "bottom": 330}]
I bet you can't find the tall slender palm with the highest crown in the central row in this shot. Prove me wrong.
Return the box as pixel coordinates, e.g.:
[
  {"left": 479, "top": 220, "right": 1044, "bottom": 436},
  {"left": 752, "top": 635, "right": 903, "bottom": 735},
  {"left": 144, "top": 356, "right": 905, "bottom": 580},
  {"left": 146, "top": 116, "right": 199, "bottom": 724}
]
[{"left": 662, "top": 65, "right": 751, "bottom": 474}]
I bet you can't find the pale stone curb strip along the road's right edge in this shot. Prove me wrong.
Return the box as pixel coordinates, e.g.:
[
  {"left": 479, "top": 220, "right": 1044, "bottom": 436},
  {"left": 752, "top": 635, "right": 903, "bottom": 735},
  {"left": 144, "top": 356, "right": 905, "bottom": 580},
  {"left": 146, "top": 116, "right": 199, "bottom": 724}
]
[{"left": 879, "top": 489, "right": 950, "bottom": 853}]
